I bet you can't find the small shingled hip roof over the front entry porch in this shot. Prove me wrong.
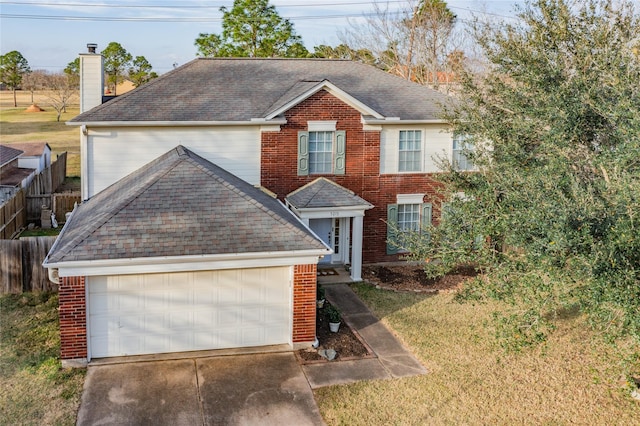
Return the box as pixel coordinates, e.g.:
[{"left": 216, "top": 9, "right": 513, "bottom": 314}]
[{"left": 286, "top": 177, "right": 373, "bottom": 209}]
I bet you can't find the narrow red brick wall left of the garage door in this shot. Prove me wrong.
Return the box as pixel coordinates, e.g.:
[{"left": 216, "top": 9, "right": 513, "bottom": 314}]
[{"left": 58, "top": 277, "right": 87, "bottom": 360}]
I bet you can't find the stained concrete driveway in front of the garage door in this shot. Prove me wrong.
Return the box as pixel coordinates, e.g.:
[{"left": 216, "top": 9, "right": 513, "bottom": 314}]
[{"left": 77, "top": 353, "right": 324, "bottom": 426}]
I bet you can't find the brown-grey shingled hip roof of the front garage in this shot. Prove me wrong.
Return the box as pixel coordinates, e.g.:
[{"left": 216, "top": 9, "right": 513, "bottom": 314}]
[{"left": 46, "top": 146, "right": 326, "bottom": 264}]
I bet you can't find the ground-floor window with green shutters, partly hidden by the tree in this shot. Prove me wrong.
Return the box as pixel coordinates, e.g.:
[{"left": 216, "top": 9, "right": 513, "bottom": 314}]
[{"left": 387, "top": 198, "right": 431, "bottom": 254}]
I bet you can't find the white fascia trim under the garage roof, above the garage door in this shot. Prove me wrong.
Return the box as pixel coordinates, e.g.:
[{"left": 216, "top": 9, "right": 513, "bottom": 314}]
[{"left": 44, "top": 247, "right": 333, "bottom": 277}]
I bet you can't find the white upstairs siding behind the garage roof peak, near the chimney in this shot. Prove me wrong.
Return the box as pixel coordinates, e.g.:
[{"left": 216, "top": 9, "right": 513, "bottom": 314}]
[{"left": 82, "top": 126, "right": 260, "bottom": 198}]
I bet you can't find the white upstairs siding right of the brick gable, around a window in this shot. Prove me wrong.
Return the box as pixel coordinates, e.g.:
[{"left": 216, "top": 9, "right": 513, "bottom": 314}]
[{"left": 380, "top": 124, "right": 453, "bottom": 174}]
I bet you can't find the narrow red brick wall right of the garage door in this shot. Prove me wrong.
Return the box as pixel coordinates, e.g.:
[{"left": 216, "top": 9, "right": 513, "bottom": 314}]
[{"left": 293, "top": 264, "right": 317, "bottom": 343}]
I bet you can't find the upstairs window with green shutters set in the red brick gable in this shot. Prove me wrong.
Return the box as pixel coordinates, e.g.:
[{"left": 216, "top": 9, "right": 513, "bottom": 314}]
[{"left": 298, "top": 130, "right": 346, "bottom": 176}]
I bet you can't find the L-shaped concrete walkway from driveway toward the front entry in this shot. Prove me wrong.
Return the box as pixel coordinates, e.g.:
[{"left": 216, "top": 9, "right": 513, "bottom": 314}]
[{"left": 302, "top": 283, "right": 427, "bottom": 389}]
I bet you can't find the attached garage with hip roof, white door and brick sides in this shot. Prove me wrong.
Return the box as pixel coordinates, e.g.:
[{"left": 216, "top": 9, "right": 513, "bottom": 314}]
[{"left": 44, "top": 146, "right": 331, "bottom": 366}]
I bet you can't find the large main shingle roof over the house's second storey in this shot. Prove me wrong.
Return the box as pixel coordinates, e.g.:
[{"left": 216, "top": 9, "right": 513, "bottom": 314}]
[{"left": 70, "top": 58, "right": 450, "bottom": 123}]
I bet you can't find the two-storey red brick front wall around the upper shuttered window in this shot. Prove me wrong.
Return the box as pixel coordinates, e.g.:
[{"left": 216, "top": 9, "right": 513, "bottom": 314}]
[{"left": 261, "top": 90, "right": 439, "bottom": 263}]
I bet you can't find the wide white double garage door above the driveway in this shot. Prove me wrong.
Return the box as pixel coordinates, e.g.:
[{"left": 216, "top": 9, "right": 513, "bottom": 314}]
[{"left": 88, "top": 267, "right": 292, "bottom": 358}]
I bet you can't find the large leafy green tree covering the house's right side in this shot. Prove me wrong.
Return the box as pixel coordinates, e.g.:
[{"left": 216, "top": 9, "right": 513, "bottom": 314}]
[{"left": 405, "top": 0, "right": 640, "bottom": 344}]
